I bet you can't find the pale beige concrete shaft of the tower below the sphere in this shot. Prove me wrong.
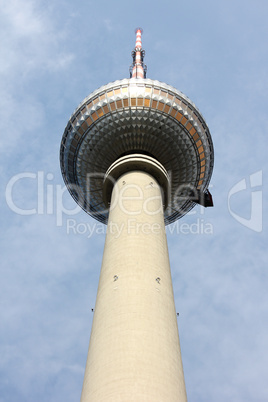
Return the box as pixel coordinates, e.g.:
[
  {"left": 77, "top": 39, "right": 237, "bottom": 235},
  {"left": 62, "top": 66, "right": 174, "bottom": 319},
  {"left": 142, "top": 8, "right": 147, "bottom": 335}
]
[{"left": 81, "top": 166, "right": 187, "bottom": 402}]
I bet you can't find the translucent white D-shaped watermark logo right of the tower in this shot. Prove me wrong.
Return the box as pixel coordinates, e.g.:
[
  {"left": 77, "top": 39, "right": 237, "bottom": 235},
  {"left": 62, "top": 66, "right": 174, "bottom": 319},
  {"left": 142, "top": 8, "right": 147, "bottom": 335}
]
[{"left": 228, "top": 170, "right": 262, "bottom": 232}]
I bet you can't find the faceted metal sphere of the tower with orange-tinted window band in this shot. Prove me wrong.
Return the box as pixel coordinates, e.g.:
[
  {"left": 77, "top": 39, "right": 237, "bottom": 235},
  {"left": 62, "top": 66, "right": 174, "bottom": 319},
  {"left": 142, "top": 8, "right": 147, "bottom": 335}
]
[{"left": 60, "top": 78, "right": 214, "bottom": 224}]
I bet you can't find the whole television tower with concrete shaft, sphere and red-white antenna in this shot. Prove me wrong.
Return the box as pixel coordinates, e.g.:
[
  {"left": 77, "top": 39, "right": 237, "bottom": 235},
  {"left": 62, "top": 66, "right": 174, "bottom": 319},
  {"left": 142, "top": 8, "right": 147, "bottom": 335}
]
[{"left": 60, "top": 28, "right": 214, "bottom": 402}]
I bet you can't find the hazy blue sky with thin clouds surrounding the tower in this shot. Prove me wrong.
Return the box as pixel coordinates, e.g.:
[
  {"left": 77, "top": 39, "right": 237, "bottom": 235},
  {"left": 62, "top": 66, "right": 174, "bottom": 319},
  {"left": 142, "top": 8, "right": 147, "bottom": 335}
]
[{"left": 0, "top": 0, "right": 268, "bottom": 402}]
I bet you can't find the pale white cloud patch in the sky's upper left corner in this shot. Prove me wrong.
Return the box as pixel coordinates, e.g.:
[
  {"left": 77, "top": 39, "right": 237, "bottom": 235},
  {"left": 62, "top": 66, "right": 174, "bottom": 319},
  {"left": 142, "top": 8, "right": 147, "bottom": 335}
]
[{"left": 0, "top": 0, "right": 74, "bottom": 77}]
